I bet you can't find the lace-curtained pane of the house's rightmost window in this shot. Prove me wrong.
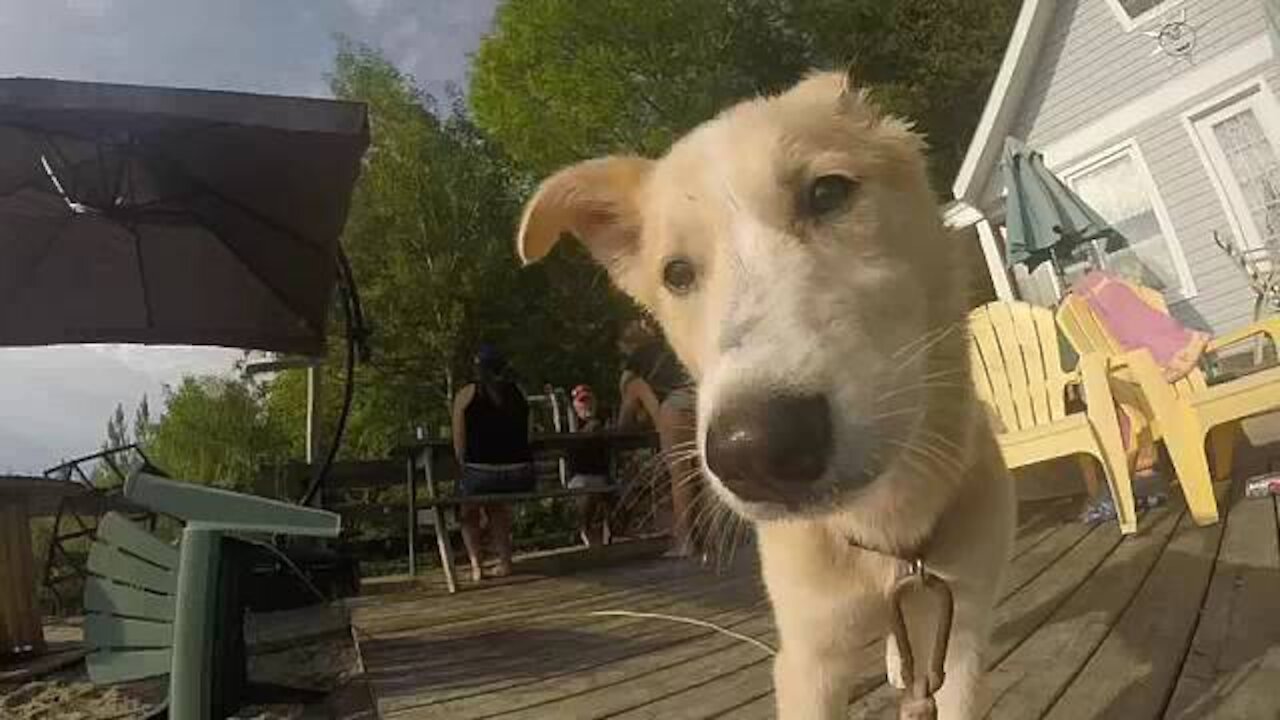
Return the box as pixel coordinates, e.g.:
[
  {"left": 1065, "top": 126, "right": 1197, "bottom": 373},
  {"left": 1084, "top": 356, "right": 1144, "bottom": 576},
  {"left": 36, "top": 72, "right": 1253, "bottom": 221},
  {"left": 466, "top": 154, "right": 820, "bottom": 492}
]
[{"left": 1213, "top": 108, "right": 1280, "bottom": 247}]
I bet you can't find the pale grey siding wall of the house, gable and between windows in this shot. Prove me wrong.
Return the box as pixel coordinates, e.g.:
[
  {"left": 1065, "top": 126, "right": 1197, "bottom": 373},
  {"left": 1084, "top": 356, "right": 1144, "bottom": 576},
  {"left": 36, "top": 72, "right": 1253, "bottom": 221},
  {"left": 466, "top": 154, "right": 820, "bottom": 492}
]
[{"left": 982, "top": 0, "right": 1280, "bottom": 332}]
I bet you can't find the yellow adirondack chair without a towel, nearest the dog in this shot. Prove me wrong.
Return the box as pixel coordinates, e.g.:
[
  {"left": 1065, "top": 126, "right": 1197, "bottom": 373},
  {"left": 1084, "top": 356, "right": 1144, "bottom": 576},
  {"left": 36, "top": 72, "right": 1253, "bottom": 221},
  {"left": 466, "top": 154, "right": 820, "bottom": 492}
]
[{"left": 969, "top": 301, "right": 1138, "bottom": 534}]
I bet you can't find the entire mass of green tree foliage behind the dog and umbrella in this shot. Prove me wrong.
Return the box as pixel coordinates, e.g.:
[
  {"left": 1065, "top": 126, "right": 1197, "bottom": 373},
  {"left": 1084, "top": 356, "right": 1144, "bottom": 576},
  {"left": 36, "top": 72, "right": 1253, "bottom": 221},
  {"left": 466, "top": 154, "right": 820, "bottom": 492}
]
[{"left": 97, "top": 0, "right": 1018, "bottom": 487}]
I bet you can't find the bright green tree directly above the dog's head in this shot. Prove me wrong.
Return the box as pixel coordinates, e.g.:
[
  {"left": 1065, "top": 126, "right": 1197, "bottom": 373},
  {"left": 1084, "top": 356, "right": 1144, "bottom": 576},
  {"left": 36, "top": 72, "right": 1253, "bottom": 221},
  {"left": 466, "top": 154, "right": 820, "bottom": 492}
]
[{"left": 471, "top": 0, "right": 1019, "bottom": 192}]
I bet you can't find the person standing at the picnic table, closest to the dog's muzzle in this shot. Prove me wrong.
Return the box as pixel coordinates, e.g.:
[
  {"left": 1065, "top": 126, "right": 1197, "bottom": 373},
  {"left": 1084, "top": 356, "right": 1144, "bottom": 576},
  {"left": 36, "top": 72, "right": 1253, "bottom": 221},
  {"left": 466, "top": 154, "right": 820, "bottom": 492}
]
[{"left": 618, "top": 320, "right": 701, "bottom": 557}]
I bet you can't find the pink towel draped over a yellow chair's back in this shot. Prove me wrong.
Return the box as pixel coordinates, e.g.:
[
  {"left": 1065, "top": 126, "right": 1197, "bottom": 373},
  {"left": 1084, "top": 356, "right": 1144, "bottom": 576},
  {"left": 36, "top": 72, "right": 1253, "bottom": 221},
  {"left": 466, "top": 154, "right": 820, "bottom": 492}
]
[{"left": 1071, "top": 270, "right": 1210, "bottom": 382}]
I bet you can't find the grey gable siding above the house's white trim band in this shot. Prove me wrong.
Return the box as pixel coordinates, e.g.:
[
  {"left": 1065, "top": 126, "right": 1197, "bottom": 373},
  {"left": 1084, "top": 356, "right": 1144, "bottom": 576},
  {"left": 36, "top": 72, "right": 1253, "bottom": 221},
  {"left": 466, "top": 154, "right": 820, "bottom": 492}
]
[{"left": 1014, "top": 0, "right": 1274, "bottom": 146}]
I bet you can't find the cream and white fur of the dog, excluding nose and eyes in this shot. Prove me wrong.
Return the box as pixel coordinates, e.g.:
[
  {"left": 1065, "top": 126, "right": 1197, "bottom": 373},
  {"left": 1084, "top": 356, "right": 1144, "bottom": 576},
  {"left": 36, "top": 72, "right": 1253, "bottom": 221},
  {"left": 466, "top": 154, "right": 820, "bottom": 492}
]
[{"left": 517, "top": 73, "right": 1014, "bottom": 720}]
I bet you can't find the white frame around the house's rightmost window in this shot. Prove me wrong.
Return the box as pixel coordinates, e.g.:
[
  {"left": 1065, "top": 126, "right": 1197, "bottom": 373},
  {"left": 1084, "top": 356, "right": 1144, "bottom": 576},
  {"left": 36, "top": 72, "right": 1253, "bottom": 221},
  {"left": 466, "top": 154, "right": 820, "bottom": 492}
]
[{"left": 1181, "top": 76, "right": 1280, "bottom": 250}]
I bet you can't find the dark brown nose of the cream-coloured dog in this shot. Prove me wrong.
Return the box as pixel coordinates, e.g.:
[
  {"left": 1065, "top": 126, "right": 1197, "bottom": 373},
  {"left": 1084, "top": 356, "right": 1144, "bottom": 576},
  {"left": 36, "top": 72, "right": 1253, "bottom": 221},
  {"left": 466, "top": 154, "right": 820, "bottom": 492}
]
[{"left": 707, "top": 395, "right": 832, "bottom": 500}]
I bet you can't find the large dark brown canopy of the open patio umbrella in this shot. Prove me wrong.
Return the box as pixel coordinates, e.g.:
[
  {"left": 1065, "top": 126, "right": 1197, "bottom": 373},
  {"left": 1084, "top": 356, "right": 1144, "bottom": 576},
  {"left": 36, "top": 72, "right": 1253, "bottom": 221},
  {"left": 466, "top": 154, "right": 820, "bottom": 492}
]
[{"left": 0, "top": 79, "right": 369, "bottom": 355}]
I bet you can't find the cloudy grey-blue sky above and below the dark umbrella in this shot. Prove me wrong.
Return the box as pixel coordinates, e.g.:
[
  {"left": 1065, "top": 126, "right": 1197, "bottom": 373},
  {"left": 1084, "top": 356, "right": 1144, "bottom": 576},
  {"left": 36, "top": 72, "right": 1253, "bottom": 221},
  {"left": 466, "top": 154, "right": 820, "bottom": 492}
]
[{"left": 0, "top": 0, "right": 497, "bottom": 473}]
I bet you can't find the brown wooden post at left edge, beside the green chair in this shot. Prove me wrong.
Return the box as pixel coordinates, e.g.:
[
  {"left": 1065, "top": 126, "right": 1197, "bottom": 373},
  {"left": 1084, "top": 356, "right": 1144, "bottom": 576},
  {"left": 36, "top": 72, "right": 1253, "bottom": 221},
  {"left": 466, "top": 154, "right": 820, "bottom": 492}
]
[{"left": 0, "top": 497, "right": 45, "bottom": 657}]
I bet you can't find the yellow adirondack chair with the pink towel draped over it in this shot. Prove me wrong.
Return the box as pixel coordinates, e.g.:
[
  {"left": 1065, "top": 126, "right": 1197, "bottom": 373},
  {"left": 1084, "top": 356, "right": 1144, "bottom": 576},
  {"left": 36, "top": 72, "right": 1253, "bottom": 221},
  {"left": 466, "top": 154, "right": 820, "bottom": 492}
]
[{"left": 1057, "top": 274, "right": 1280, "bottom": 525}]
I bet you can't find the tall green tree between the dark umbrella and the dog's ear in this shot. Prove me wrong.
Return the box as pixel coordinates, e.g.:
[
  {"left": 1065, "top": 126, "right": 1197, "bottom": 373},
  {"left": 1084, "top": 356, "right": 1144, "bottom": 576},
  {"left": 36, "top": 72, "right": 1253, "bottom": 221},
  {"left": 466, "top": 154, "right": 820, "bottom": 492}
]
[{"left": 276, "top": 41, "right": 634, "bottom": 456}]
